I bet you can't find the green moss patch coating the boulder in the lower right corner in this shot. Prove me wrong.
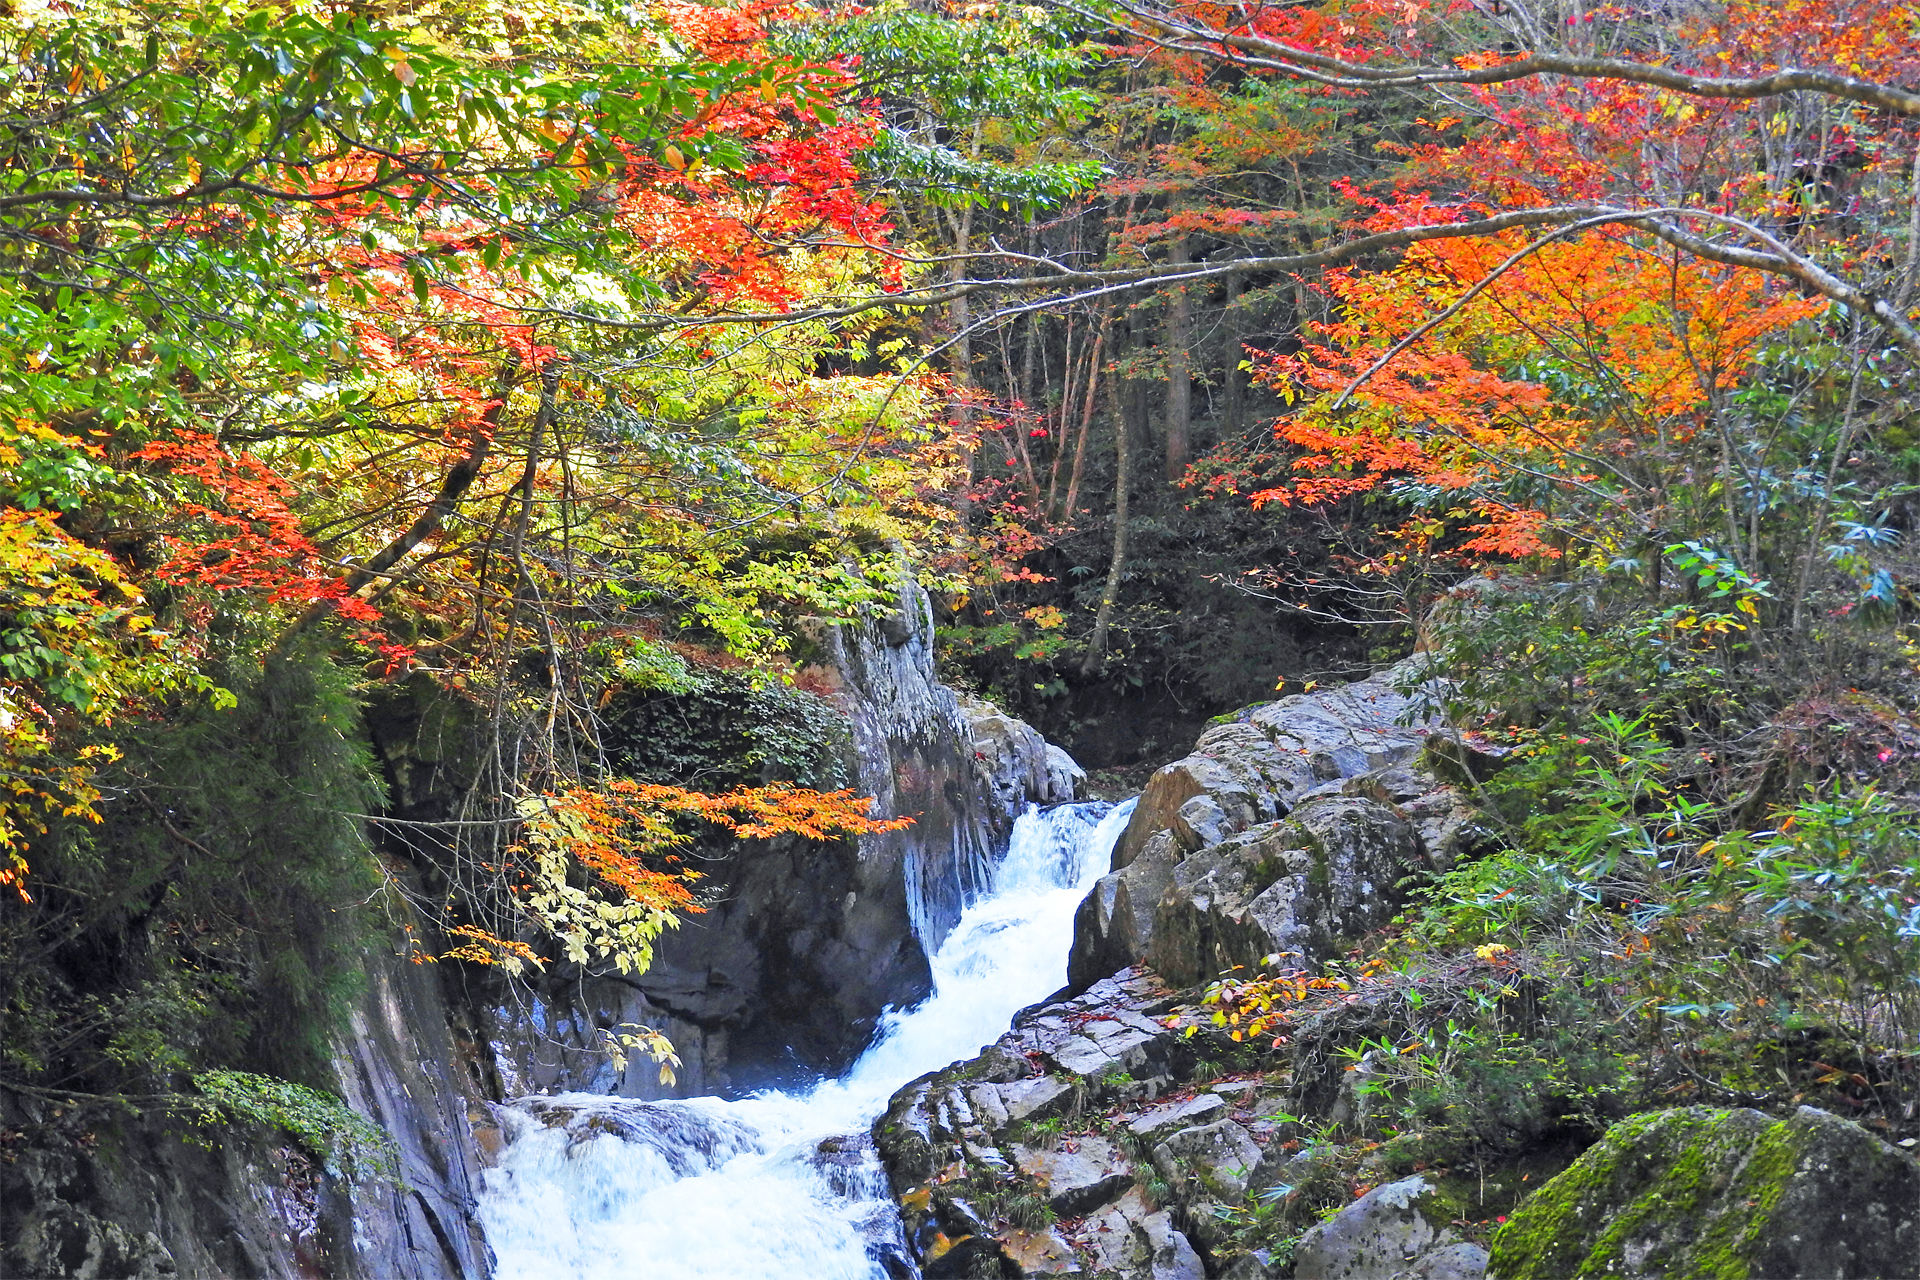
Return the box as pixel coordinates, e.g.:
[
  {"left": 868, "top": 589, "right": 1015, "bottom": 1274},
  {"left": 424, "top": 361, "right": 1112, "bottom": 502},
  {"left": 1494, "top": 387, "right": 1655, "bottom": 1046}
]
[{"left": 1488, "top": 1107, "right": 1803, "bottom": 1280}]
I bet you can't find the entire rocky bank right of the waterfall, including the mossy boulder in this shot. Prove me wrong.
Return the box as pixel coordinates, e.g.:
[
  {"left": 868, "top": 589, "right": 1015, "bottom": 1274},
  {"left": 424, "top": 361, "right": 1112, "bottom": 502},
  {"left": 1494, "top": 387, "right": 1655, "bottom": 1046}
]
[{"left": 874, "top": 664, "right": 1920, "bottom": 1280}]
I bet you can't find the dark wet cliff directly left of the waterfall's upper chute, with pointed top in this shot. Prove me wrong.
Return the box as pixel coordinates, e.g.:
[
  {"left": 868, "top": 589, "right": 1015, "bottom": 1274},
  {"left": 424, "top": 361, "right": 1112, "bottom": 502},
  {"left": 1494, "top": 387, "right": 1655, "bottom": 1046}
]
[{"left": 468, "top": 580, "right": 1085, "bottom": 1098}]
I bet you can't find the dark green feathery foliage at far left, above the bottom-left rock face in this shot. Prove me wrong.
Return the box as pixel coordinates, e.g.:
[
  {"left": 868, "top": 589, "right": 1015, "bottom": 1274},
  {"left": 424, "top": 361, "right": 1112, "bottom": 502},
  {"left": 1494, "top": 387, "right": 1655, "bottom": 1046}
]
[{"left": 0, "top": 656, "right": 380, "bottom": 1094}]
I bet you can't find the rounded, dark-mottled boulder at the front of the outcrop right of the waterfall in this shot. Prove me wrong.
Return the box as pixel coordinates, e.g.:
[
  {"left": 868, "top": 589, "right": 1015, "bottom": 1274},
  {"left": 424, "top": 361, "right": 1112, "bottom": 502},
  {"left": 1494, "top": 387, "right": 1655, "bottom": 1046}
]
[{"left": 1146, "top": 796, "right": 1423, "bottom": 984}]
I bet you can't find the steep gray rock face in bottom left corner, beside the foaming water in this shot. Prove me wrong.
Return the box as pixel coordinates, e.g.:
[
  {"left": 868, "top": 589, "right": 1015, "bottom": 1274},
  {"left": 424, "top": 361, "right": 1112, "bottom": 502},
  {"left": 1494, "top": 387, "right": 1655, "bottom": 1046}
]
[{"left": 0, "top": 932, "right": 490, "bottom": 1280}]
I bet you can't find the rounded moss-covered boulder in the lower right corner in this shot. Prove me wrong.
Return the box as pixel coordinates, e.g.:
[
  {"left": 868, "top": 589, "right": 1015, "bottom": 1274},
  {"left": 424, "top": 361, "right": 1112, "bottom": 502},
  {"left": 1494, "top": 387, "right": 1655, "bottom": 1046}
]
[{"left": 1486, "top": 1107, "right": 1920, "bottom": 1280}]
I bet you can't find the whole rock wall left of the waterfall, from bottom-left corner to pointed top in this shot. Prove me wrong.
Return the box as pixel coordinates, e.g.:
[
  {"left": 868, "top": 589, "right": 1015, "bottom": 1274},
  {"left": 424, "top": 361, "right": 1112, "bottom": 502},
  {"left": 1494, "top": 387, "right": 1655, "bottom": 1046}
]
[{"left": 0, "top": 581, "right": 1085, "bottom": 1280}]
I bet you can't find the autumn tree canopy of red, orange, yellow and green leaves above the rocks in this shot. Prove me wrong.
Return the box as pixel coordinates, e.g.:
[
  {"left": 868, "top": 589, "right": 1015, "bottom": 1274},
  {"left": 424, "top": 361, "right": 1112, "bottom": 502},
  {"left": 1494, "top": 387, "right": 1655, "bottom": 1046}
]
[{"left": 0, "top": 0, "right": 1920, "bottom": 1105}]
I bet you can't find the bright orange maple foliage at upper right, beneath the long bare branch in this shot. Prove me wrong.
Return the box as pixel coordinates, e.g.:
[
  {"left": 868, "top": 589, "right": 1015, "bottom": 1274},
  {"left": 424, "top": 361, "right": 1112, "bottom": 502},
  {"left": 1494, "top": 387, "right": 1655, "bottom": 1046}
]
[{"left": 1252, "top": 214, "right": 1824, "bottom": 557}]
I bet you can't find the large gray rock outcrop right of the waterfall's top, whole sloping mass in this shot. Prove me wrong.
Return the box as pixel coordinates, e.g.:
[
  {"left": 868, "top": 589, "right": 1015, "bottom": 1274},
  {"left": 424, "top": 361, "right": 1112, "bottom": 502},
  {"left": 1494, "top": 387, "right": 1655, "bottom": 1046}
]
[{"left": 1068, "top": 658, "right": 1476, "bottom": 988}]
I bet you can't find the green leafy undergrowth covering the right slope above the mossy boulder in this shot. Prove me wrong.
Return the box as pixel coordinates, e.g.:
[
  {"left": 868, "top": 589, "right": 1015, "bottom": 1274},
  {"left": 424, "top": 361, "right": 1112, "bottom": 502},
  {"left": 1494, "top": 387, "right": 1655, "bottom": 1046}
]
[{"left": 1305, "top": 579, "right": 1920, "bottom": 1165}]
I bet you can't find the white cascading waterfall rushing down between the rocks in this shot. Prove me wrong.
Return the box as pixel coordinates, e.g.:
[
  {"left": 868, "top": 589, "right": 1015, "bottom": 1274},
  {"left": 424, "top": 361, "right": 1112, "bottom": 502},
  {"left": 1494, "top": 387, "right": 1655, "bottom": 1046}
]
[{"left": 480, "top": 800, "right": 1133, "bottom": 1280}]
